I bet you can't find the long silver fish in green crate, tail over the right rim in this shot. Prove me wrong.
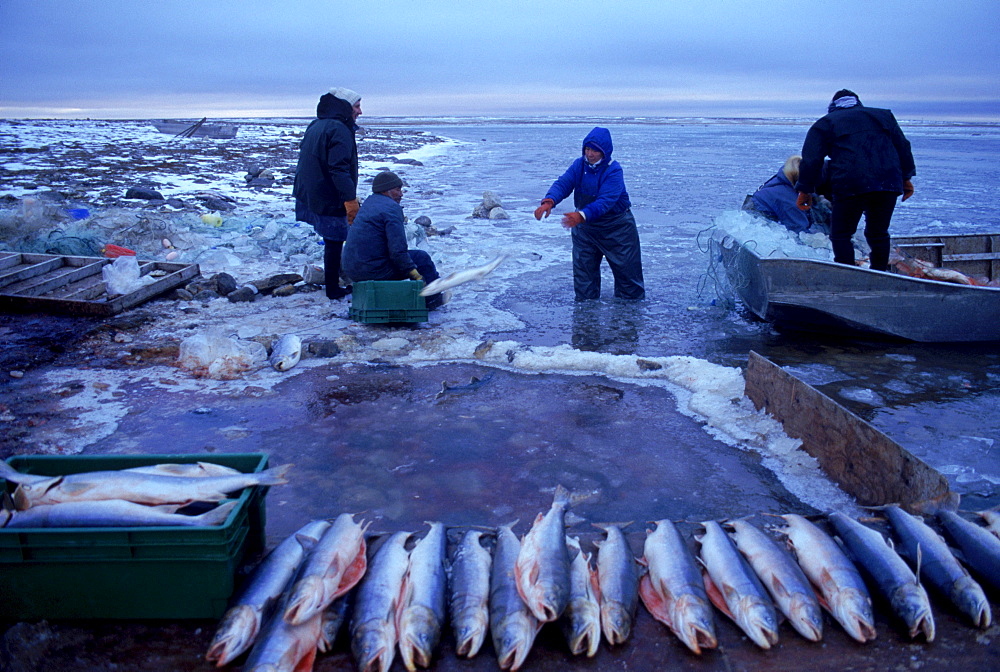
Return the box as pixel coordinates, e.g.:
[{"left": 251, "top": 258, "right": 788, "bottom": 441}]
[{"left": 14, "top": 464, "right": 292, "bottom": 510}]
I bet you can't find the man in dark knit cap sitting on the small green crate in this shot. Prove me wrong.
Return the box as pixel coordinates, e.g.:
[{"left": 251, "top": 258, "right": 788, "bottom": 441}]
[{"left": 341, "top": 170, "right": 444, "bottom": 310}]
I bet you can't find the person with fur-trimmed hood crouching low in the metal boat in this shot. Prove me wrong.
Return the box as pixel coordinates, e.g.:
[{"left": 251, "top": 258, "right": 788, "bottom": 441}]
[{"left": 742, "top": 154, "right": 830, "bottom": 233}]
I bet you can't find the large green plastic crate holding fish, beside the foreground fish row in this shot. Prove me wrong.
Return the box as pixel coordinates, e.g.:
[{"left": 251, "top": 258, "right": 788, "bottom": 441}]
[{"left": 0, "top": 453, "right": 276, "bottom": 621}]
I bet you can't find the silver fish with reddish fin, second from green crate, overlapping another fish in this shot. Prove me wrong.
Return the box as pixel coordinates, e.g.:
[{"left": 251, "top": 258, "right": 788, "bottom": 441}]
[{"left": 284, "top": 513, "right": 368, "bottom": 625}]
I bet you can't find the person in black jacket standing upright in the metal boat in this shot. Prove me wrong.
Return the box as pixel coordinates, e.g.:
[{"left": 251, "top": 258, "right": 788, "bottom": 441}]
[{"left": 795, "top": 89, "right": 917, "bottom": 271}]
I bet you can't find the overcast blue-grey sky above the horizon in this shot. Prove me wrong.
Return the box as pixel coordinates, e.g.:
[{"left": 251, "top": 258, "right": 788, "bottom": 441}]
[{"left": 0, "top": 0, "right": 1000, "bottom": 120}]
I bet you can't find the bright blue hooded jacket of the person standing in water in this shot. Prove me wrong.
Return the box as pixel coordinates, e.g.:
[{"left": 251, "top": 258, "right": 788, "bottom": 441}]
[{"left": 545, "top": 126, "right": 632, "bottom": 224}]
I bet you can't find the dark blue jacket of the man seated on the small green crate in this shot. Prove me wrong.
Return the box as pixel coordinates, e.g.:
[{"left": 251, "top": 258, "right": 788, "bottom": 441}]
[{"left": 341, "top": 194, "right": 417, "bottom": 282}]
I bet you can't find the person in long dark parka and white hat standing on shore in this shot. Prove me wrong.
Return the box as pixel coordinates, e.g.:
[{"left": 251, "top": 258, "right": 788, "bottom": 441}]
[{"left": 292, "top": 88, "right": 361, "bottom": 299}]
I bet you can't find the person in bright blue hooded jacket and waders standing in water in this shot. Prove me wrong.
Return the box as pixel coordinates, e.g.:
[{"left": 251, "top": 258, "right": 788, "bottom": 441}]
[{"left": 535, "top": 127, "right": 646, "bottom": 301}]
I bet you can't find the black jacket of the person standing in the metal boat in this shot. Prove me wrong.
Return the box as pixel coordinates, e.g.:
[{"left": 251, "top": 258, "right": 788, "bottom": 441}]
[{"left": 795, "top": 105, "right": 917, "bottom": 199}]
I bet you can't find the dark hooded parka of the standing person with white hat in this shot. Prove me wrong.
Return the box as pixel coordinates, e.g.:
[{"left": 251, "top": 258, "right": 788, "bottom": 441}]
[{"left": 292, "top": 93, "right": 358, "bottom": 221}]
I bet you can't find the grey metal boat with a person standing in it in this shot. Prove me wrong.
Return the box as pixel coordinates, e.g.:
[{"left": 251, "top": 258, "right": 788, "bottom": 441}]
[{"left": 712, "top": 233, "right": 1000, "bottom": 343}]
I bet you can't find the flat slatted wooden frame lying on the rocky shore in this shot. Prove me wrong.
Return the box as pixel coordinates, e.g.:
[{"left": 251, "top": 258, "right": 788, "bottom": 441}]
[{"left": 0, "top": 251, "right": 200, "bottom": 316}]
